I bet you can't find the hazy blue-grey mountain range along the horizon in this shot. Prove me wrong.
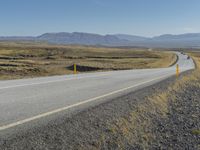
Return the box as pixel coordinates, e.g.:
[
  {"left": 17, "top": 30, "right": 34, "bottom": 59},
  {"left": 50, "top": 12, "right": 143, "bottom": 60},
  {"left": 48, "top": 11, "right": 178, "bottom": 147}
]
[{"left": 0, "top": 32, "right": 200, "bottom": 48}]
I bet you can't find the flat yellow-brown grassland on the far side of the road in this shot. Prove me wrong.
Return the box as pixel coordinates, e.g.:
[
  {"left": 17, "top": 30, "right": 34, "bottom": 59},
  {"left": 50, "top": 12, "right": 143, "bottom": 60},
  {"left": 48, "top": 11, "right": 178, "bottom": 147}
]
[{"left": 0, "top": 42, "right": 176, "bottom": 79}]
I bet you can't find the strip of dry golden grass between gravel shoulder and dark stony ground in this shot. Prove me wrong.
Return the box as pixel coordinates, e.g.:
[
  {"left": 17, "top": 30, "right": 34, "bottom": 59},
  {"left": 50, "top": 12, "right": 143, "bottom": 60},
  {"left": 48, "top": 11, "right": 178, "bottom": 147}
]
[{"left": 95, "top": 50, "right": 200, "bottom": 149}]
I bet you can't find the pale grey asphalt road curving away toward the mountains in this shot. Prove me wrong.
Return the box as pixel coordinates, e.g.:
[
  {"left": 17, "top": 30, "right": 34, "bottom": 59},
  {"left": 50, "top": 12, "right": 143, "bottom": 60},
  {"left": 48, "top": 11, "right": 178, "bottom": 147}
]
[{"left": 0, "top": 53, "right": 194, "bottom": 133}]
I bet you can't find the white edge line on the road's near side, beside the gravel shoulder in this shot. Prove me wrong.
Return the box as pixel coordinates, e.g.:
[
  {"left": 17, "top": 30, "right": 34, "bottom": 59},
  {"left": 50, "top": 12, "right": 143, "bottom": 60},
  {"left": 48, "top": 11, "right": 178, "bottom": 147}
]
[{"left": 0, "top": 73, "right": 173, "bottom": 131}]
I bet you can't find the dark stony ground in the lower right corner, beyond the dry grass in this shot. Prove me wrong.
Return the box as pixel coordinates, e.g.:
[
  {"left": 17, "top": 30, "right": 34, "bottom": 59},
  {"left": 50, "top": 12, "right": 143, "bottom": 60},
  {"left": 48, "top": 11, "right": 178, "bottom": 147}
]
[{"left": 149, "top": 80, "right": 200, "bottom": 150}]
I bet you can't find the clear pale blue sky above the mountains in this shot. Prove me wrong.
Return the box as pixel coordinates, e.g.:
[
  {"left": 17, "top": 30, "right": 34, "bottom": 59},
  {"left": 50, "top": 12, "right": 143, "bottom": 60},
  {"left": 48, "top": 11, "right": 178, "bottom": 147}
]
[{"left": 0, "top": 0, "right": 200, "bottom": 36}]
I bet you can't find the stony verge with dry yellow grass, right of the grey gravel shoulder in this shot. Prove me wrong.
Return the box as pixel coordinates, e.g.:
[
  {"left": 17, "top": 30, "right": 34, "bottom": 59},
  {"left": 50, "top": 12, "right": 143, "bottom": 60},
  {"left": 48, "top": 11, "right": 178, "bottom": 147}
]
[{"left": 95, "top": 52, "right": 200, "bottom": 149}]
